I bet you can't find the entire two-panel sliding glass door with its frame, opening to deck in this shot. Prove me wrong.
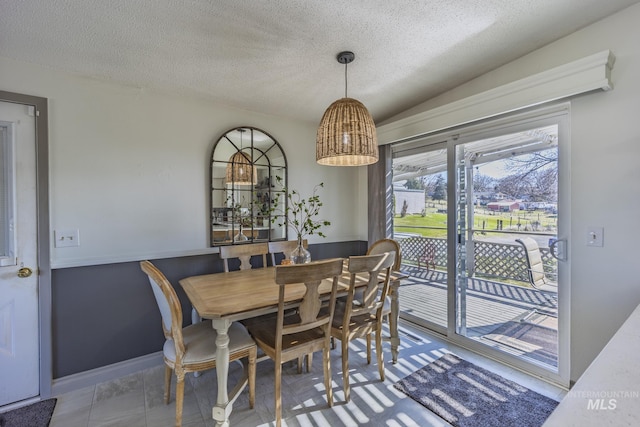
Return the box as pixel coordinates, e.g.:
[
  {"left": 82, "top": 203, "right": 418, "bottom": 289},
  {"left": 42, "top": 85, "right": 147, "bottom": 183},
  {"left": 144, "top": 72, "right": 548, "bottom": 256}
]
[{"left": 393, "top": 106, "right": 568, "bottom": 384}]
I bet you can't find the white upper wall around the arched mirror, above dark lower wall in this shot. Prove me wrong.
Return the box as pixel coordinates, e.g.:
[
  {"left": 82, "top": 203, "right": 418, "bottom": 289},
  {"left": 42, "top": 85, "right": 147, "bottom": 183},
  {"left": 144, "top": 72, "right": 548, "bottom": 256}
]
[{"left": 0, "top": 57, "right": 367, "bottom": 267}]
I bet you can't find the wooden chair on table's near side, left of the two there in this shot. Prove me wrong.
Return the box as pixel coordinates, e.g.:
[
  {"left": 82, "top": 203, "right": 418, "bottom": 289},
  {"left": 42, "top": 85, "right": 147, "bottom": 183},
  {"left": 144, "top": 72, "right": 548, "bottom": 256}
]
[{"left": 249, "top": 258, "right": 343, "bottom": 427}]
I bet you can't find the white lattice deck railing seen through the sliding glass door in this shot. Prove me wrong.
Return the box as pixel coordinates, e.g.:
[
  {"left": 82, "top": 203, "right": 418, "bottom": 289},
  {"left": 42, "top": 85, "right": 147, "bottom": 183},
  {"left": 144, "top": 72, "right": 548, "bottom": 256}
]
[{"left": 397, "top": 236, "right": 555, "bottom": 282}]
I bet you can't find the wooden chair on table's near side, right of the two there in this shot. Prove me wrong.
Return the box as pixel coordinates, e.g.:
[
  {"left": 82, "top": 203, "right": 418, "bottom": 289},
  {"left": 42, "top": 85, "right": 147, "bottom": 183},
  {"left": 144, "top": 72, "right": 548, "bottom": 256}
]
[{"left": 331, "top": 251, "right": 395, "bottom": 402}]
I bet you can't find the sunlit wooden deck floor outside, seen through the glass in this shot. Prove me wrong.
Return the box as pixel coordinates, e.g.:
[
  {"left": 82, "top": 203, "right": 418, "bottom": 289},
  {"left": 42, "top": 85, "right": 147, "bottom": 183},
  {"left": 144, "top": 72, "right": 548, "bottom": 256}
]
[{"left": 399, "top": 265, "right": 558, "bottom": 364}]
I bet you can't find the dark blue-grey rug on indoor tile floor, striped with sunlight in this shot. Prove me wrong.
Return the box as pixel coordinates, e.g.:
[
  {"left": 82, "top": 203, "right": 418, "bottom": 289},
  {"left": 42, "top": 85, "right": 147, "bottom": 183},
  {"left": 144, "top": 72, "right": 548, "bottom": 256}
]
[{"left": 395, "top": 354, "right": 558, "bottom": 427}]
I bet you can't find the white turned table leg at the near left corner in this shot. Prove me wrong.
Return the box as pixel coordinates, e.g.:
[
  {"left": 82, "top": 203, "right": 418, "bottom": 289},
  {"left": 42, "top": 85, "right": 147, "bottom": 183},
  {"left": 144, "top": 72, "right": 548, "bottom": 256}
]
[{"left": 211, "top": 319, "right": 233, "bottom": 427}]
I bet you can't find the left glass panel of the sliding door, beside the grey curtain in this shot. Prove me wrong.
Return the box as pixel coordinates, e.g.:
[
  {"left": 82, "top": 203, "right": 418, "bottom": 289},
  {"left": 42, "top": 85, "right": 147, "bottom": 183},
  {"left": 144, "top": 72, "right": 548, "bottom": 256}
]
[{"left": 393, "top": 140, "right": 448, "bottom": 334}]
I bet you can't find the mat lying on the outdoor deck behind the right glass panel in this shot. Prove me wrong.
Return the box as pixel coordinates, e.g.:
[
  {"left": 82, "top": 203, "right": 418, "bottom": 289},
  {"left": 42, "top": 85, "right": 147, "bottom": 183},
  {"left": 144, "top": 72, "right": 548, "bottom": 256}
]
[{"left": 484, "top": 313, "right": 558, "bottom": 367}]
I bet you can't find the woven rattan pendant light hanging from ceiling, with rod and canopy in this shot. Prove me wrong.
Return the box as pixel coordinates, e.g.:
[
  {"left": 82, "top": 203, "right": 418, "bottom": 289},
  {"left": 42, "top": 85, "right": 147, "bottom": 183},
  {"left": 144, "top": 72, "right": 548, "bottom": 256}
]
[{"left": 316, "top": 52, "right": 378, "bottom": 166}]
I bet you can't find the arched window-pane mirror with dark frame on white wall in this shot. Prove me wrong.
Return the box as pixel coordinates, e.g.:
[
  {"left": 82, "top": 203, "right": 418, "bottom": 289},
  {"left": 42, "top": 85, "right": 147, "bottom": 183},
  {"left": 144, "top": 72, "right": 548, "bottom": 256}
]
[{"left": 210, "top": 126, "right": 287, "bottom": 246}]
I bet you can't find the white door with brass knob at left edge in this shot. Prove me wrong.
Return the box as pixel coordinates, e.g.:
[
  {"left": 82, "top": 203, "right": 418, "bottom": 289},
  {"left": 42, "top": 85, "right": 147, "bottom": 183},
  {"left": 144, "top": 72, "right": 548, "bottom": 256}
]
[{"left": 0, "top": 102, "right": 40, "bottom": 406}]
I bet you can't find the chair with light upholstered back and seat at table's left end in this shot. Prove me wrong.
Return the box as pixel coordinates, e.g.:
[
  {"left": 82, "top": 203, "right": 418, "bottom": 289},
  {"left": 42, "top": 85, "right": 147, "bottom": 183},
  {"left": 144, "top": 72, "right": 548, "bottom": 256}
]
[{"left": 140, "top": 261, "right": 257, "bottom": 426}]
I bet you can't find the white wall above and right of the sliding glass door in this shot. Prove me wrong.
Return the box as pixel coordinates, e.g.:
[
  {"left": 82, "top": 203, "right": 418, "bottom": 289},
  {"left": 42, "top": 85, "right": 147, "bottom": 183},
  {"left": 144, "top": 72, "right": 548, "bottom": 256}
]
[{"left": 386, "top": 4, "right": 640, "bottom": 380}]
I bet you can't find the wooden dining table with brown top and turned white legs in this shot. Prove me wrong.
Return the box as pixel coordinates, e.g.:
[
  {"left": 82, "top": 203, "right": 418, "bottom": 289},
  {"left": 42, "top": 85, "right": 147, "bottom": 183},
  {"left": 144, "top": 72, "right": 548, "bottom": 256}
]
[{"left": 180, "top": 263, "right": 406, "bottom": 427}]
